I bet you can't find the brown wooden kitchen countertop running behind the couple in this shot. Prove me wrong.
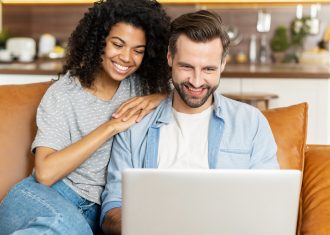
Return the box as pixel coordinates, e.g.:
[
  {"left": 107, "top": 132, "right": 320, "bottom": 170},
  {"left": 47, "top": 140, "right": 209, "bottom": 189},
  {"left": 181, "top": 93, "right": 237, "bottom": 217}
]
[{"left": 0, "top": 60, "right": 330, "bottom": 79}]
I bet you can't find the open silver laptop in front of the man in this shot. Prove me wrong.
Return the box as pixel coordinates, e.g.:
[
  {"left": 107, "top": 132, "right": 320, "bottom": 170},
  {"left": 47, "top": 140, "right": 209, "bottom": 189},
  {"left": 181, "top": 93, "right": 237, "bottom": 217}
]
[{"left": 122, "top": 169, "right": 302, "bottom": 235}]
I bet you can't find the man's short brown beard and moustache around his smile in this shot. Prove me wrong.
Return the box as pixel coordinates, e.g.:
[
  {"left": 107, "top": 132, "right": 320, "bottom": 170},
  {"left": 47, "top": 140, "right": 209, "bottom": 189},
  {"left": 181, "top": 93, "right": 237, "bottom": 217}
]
[{"left": 173, "top": 81, "right": 219, "bottom": 108}]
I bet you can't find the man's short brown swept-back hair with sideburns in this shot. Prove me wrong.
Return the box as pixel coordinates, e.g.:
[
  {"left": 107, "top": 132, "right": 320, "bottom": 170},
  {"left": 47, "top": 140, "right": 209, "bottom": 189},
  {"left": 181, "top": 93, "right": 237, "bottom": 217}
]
[{"left": 169, "top": 10, "right": 230, "bottom": 59}]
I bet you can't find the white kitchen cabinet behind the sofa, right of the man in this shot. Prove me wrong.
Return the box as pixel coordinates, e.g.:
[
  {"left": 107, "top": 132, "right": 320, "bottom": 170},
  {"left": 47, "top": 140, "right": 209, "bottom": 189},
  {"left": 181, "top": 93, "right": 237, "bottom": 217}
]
[{"left": 218, "top": 78, "right": 330, "bottom": 144}]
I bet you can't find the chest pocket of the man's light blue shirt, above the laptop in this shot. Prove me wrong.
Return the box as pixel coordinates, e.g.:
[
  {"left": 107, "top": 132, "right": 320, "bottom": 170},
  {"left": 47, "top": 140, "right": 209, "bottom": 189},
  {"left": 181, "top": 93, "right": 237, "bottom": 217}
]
[{"left": 217, "top": 149, "right": 250, "bottom": 169}]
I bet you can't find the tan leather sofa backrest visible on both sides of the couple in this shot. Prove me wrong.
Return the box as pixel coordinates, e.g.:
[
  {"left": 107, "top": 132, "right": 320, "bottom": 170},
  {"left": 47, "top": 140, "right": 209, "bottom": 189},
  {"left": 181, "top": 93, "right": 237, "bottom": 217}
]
[{"left": 0, "top": 82, "right": 307, "bottom": 201}]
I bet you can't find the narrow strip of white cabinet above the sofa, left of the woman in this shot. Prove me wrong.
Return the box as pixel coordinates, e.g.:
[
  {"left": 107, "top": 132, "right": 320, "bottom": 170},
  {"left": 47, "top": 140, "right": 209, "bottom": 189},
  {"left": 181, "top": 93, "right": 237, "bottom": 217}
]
[{"left": 0, "top": 74, "right": 57, "bottom": 85}]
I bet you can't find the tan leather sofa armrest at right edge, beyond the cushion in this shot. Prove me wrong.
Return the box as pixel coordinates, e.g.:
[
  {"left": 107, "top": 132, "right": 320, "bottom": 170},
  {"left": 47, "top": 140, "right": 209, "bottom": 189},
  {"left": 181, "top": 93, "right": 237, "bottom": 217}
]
[{"left": 300, "top": 145, "right": 330, "bottom": 235}]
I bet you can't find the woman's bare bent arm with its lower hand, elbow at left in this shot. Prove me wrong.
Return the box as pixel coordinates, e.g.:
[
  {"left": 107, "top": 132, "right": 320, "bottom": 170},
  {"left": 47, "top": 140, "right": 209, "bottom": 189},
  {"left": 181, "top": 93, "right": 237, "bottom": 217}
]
[{"left": 35, "top": 112, "right": 140, "bottom": 186}]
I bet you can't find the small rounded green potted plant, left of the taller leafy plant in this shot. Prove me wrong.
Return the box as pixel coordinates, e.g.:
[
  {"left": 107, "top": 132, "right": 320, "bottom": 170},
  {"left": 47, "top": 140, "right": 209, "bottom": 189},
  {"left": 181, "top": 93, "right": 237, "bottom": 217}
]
[{"left": 270, "top": 26, "right": 289, "bottom": 63}]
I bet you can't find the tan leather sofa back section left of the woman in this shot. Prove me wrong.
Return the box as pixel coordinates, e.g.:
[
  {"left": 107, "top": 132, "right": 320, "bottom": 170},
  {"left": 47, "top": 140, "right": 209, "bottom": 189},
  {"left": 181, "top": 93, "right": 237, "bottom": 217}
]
[{"left": 0, "top": 82, "right": 50, "bottom": 201}]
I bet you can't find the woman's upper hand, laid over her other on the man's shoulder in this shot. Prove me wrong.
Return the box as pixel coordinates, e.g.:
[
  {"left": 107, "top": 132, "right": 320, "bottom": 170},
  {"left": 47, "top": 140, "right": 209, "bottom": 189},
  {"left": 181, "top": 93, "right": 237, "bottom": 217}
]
[{"left": 112, "top": 94, "right": 167, "bottom": 122}]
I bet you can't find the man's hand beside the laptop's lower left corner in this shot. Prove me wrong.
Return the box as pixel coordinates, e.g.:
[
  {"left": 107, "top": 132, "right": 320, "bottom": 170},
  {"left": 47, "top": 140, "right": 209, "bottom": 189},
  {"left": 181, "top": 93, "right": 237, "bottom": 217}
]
[{"left": 102, "top": 208, "right": 121, "bottom": 235}]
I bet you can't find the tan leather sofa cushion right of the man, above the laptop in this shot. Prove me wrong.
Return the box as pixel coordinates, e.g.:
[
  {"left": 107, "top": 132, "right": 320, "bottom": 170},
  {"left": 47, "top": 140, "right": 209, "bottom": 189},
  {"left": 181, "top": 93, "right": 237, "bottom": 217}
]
[{"left": 263, "top": 103, "right": 308, "bottom": 170}]
